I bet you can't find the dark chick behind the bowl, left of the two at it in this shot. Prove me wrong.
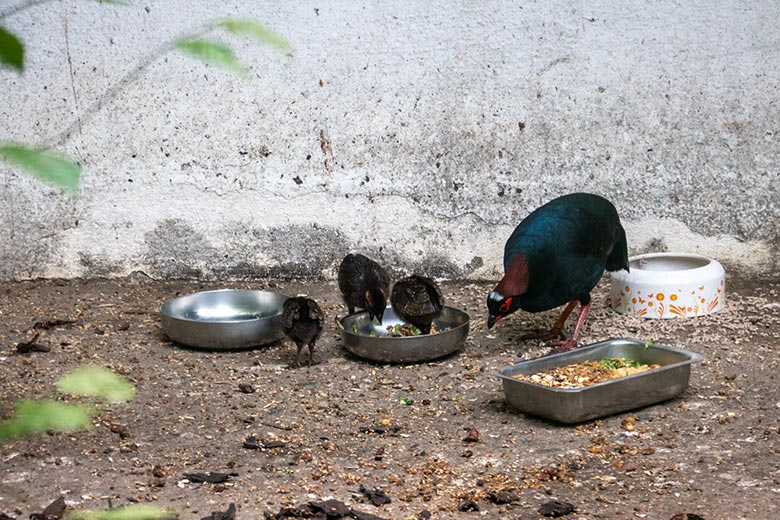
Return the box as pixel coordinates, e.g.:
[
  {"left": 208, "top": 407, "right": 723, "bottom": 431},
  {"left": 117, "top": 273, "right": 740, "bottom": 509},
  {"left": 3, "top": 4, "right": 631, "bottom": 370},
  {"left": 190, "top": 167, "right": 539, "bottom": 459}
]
[{"left": 339, "top": 253, "right": 390, "bottom": 325}]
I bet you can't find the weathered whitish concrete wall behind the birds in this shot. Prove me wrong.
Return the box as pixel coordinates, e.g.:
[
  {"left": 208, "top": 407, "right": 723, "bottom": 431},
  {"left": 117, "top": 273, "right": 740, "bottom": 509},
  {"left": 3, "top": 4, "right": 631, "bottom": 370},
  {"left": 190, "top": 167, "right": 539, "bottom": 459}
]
[{"left": 0, "top": 0, "right": 780, "bottom": 280}]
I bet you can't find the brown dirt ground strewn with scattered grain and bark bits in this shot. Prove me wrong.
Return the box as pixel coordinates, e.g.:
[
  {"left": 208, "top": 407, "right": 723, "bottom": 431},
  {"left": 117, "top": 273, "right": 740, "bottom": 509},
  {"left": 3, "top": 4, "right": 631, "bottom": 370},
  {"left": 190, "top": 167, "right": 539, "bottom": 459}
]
[{"left": 0, "top": 275, "right": 780, "bottom": 520}]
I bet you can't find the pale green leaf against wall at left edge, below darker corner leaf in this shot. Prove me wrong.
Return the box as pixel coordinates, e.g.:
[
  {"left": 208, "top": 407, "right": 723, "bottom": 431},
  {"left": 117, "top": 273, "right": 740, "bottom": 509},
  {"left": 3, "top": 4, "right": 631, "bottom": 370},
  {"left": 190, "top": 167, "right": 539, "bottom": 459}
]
[{"left": 0, "top": 144, "right": 81, "bottom": 193}]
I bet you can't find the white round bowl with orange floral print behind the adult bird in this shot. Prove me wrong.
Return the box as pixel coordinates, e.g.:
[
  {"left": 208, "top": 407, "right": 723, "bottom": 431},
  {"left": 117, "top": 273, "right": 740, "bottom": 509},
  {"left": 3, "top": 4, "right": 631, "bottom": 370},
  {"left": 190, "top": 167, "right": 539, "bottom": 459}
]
[{"left": 610, "top": 253, "right": 726, "bottom": 318}]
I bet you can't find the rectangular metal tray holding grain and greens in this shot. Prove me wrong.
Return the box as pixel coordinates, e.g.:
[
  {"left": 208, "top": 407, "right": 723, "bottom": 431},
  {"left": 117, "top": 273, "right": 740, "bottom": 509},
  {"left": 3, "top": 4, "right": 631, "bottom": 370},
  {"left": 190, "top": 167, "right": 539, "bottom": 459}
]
[{"left": 495, "top": 339, "right": 703, "bottom": 424}]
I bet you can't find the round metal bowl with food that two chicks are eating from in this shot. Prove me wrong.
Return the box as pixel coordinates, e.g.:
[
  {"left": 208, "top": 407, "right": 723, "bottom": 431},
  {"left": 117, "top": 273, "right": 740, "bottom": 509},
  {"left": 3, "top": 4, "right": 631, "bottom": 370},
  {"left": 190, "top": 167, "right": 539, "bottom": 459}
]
[{"left": 339, "top": 305, "right": 469, "bottom": 363}]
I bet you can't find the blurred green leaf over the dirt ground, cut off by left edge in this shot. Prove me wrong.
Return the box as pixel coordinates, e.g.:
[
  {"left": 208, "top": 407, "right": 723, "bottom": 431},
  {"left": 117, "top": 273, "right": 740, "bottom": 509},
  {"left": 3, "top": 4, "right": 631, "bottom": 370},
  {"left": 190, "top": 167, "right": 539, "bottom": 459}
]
[{"left": 0, "top": 399, "right": 96, "bottom": 439}]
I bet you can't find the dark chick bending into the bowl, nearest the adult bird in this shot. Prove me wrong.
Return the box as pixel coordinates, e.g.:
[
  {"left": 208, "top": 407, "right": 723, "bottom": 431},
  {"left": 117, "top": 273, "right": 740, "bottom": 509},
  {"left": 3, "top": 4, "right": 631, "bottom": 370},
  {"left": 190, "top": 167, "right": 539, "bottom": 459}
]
[{"left": 390, "top": 274, "right": 444, "bottom": 334}]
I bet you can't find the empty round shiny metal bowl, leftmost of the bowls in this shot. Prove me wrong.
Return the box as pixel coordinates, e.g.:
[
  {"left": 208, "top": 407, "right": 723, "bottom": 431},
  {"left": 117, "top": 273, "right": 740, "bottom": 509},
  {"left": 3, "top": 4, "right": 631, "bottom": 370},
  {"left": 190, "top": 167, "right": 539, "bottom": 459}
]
[{"left": 160, "top": 289, "right": 287, "bottom": 350}]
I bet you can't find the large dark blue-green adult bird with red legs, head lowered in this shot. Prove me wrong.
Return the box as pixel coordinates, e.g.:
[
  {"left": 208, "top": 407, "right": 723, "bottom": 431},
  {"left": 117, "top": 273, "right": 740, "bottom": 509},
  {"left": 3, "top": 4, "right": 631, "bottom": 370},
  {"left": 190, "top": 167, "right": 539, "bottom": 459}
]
[{"left": 487, "top": 193, "right": 628, "bottom": 351}]
